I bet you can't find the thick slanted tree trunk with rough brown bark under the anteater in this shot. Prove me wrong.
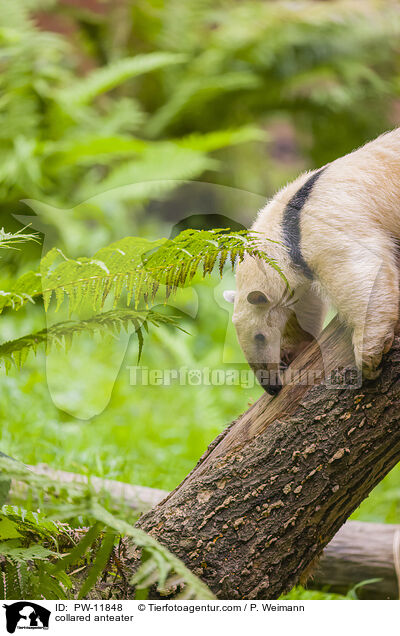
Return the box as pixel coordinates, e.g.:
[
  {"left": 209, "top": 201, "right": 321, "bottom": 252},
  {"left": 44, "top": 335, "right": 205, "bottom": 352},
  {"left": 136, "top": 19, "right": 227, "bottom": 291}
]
[{"left": 131, "top": 320, "right": 400, "bottom": 600}]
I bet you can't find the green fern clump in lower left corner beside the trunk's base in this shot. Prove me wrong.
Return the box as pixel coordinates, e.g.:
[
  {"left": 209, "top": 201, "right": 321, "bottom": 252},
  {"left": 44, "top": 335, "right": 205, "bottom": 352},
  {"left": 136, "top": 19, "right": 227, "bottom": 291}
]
[{"left": 0, "top": 458, "right": 214, "bottom": 599}]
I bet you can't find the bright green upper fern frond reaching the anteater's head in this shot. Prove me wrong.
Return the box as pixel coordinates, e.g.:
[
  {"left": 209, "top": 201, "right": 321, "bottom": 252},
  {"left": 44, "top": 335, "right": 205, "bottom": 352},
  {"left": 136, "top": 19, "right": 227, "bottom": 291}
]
[{"left": 0, "top": 229, "right": 288, "bottom": 312}]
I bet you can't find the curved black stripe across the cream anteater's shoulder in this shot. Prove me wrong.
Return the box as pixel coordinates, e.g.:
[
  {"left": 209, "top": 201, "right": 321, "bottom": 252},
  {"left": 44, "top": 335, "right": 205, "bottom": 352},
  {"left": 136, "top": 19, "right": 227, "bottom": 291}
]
[{"left": 282, "top": 168, "right": 325, "bottom": 279}]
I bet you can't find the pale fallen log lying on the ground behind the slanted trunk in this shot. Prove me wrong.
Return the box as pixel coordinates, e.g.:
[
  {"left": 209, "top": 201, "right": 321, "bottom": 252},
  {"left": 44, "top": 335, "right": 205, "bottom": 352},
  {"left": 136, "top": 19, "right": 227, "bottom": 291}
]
[{"left": 12, "top": 464, "right": 400, "bottom": 599}]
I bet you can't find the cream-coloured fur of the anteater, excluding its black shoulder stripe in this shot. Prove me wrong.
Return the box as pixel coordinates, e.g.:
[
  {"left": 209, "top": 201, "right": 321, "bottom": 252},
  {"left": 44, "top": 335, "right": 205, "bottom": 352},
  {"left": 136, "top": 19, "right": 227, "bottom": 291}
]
[{"left": 227, "top": 129, "right": 400, "bottom": 388}]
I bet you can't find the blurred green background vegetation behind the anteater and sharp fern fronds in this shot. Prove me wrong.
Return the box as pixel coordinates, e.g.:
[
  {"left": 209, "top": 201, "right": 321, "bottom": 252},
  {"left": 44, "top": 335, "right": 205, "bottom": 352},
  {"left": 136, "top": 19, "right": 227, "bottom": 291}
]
[{"left": 0, "top": 0, "right": 400, "bottom": 598}]
